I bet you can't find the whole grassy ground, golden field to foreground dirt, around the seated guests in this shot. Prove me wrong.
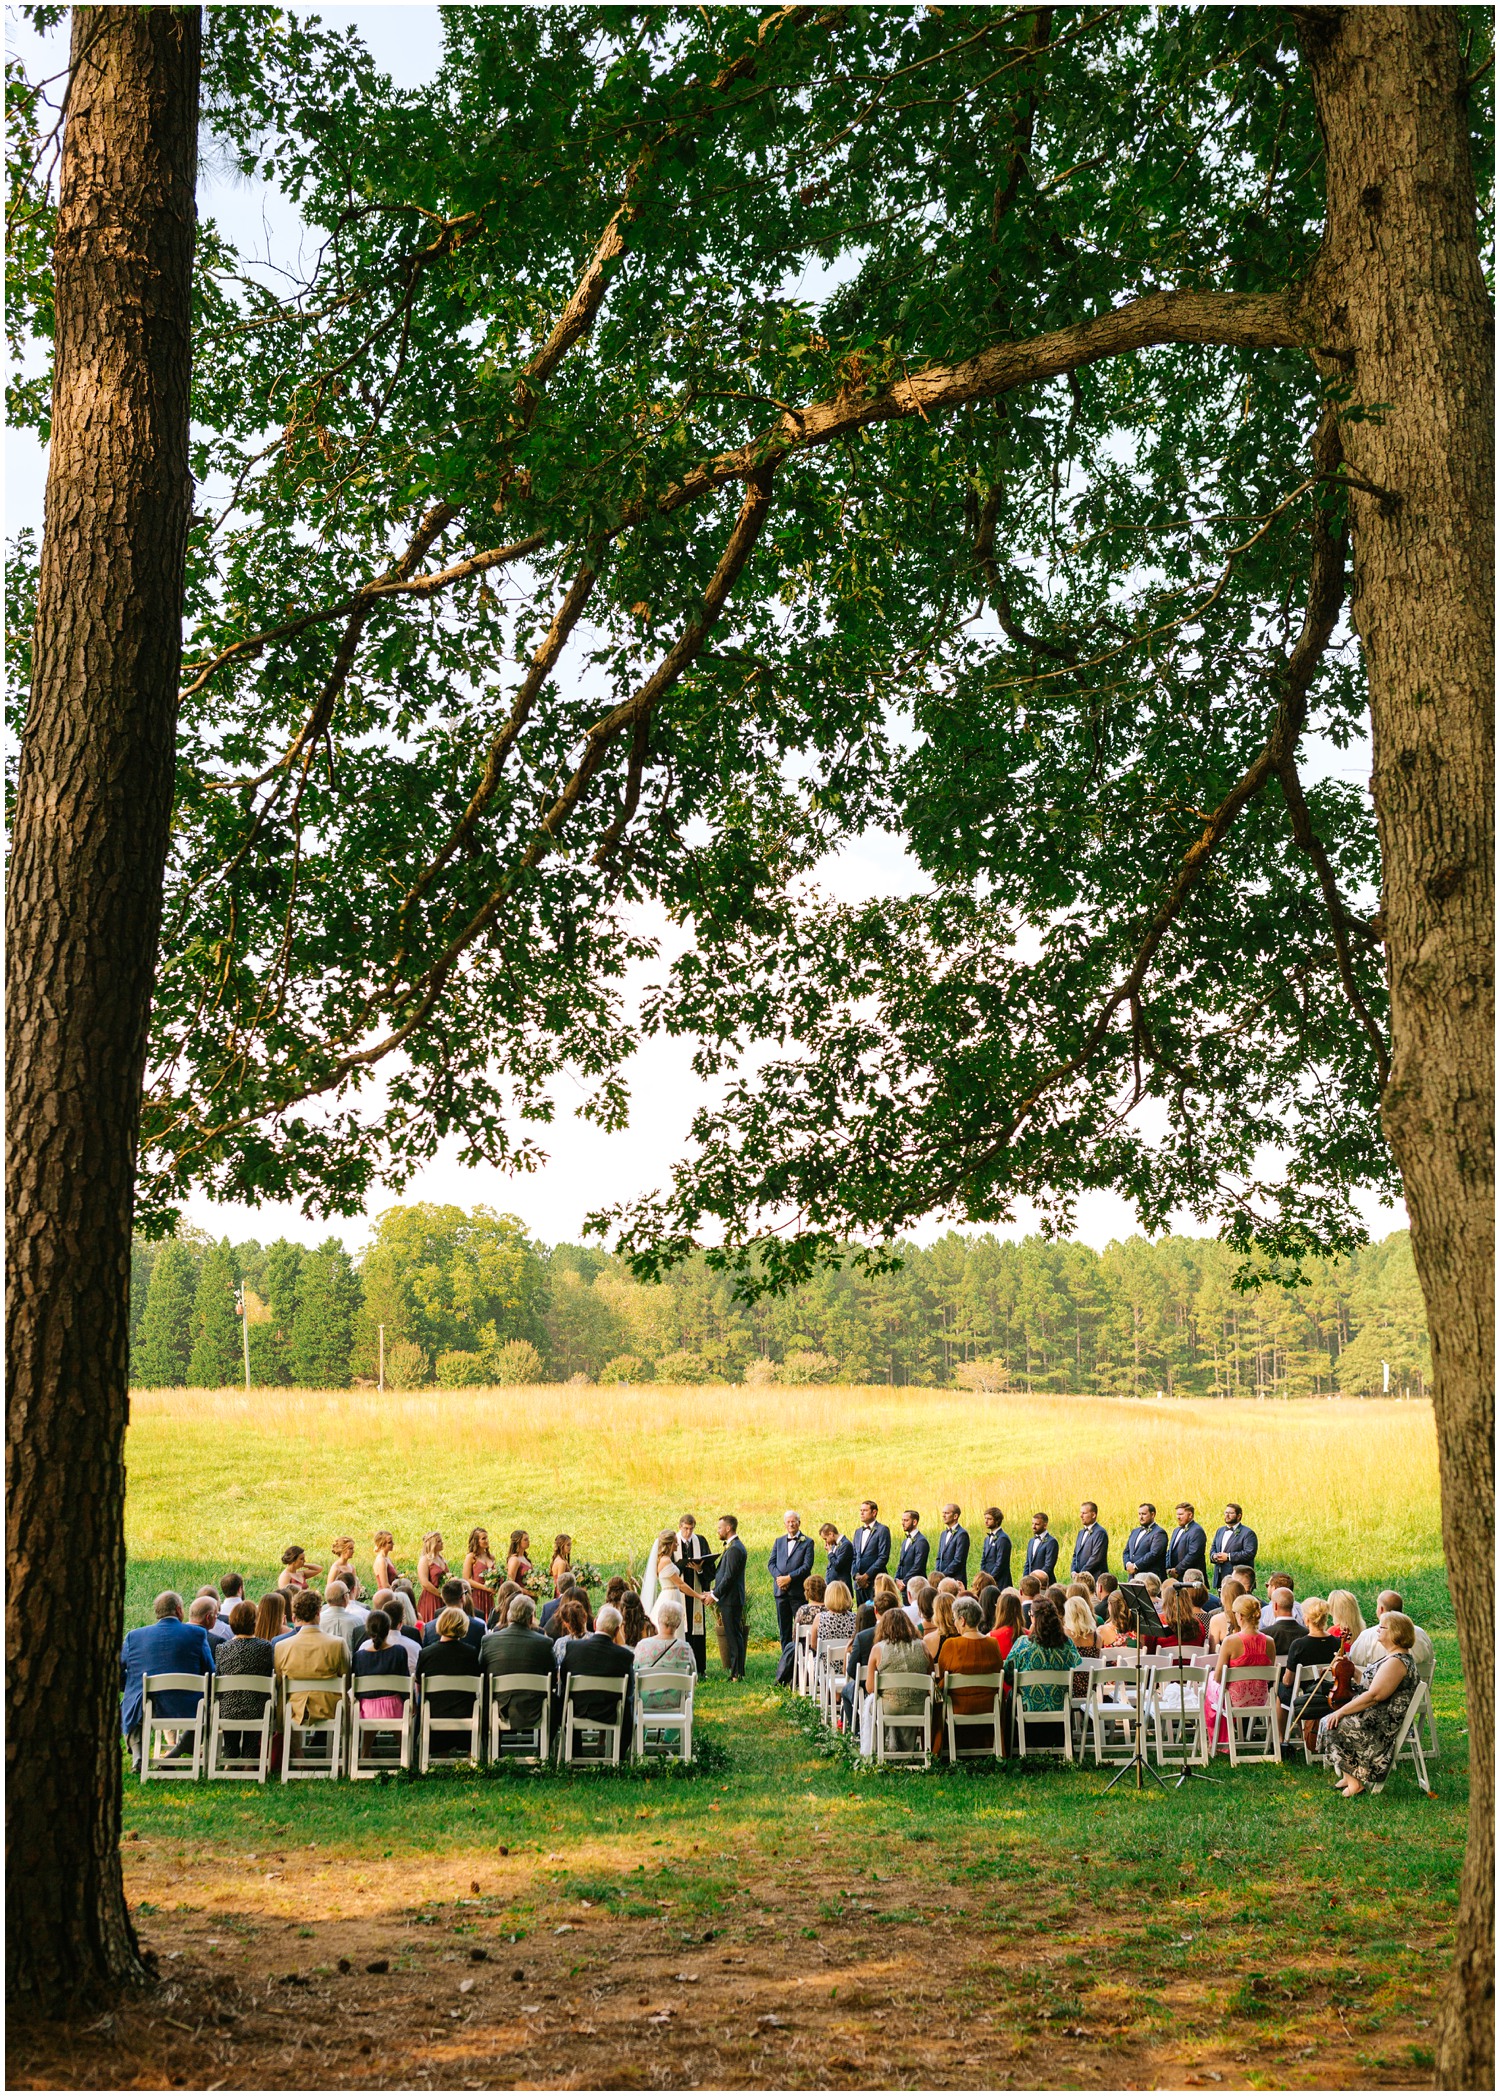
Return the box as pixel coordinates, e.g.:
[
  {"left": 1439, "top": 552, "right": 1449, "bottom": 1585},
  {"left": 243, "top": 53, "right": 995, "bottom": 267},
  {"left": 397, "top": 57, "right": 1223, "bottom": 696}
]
[{"left": 10, "top": 1390, "right": 1466, "bottom": 2088}]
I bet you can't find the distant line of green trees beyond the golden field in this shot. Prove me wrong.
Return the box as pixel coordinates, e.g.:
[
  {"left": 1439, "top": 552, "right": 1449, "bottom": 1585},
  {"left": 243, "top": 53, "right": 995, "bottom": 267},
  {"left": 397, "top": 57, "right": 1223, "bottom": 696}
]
[{"left": 130, "top": 1203, "right": 1431, "bottom": 1398}]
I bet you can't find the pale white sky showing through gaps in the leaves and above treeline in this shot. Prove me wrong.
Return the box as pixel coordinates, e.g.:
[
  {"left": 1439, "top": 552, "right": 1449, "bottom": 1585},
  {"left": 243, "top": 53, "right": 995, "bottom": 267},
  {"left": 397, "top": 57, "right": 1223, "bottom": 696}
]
[{"left": 6, "top": 4, "right": 1406, "bottom": 1249}]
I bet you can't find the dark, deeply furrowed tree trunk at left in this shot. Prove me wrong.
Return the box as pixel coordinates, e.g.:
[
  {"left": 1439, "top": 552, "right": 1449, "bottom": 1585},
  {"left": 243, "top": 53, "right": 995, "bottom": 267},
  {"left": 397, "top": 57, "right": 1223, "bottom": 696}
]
[{"left": 6, "top": 6, "right": 201, "bottom": 2010}]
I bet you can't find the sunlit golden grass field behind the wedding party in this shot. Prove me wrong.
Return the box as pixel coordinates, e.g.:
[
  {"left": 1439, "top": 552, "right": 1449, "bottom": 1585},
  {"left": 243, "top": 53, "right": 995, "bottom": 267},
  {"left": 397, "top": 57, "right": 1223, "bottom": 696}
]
[{"left": 126, "top": 1388, "right": 1441, "bottom": 1580}]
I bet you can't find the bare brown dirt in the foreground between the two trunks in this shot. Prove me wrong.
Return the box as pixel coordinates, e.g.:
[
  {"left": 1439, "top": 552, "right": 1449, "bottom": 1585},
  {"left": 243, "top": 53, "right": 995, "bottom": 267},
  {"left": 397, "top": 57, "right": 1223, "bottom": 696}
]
[{"left": 8, "top": 1838, "right": 1439, "bottom": 2090}]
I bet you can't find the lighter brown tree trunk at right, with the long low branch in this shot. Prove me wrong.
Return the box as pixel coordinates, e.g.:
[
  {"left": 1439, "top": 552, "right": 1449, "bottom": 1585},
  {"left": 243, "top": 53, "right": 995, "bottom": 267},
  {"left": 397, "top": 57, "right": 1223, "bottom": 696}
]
[{"left": 1299, "top": 6, "right": 1494, "bottom": 2090}]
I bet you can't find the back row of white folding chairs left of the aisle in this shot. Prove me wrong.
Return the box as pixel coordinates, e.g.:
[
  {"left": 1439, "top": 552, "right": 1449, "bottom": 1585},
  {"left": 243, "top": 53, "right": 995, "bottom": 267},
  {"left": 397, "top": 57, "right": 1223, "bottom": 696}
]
[{"left": 140, "top": 1668, "right": 698, "bottom": 1784}]
